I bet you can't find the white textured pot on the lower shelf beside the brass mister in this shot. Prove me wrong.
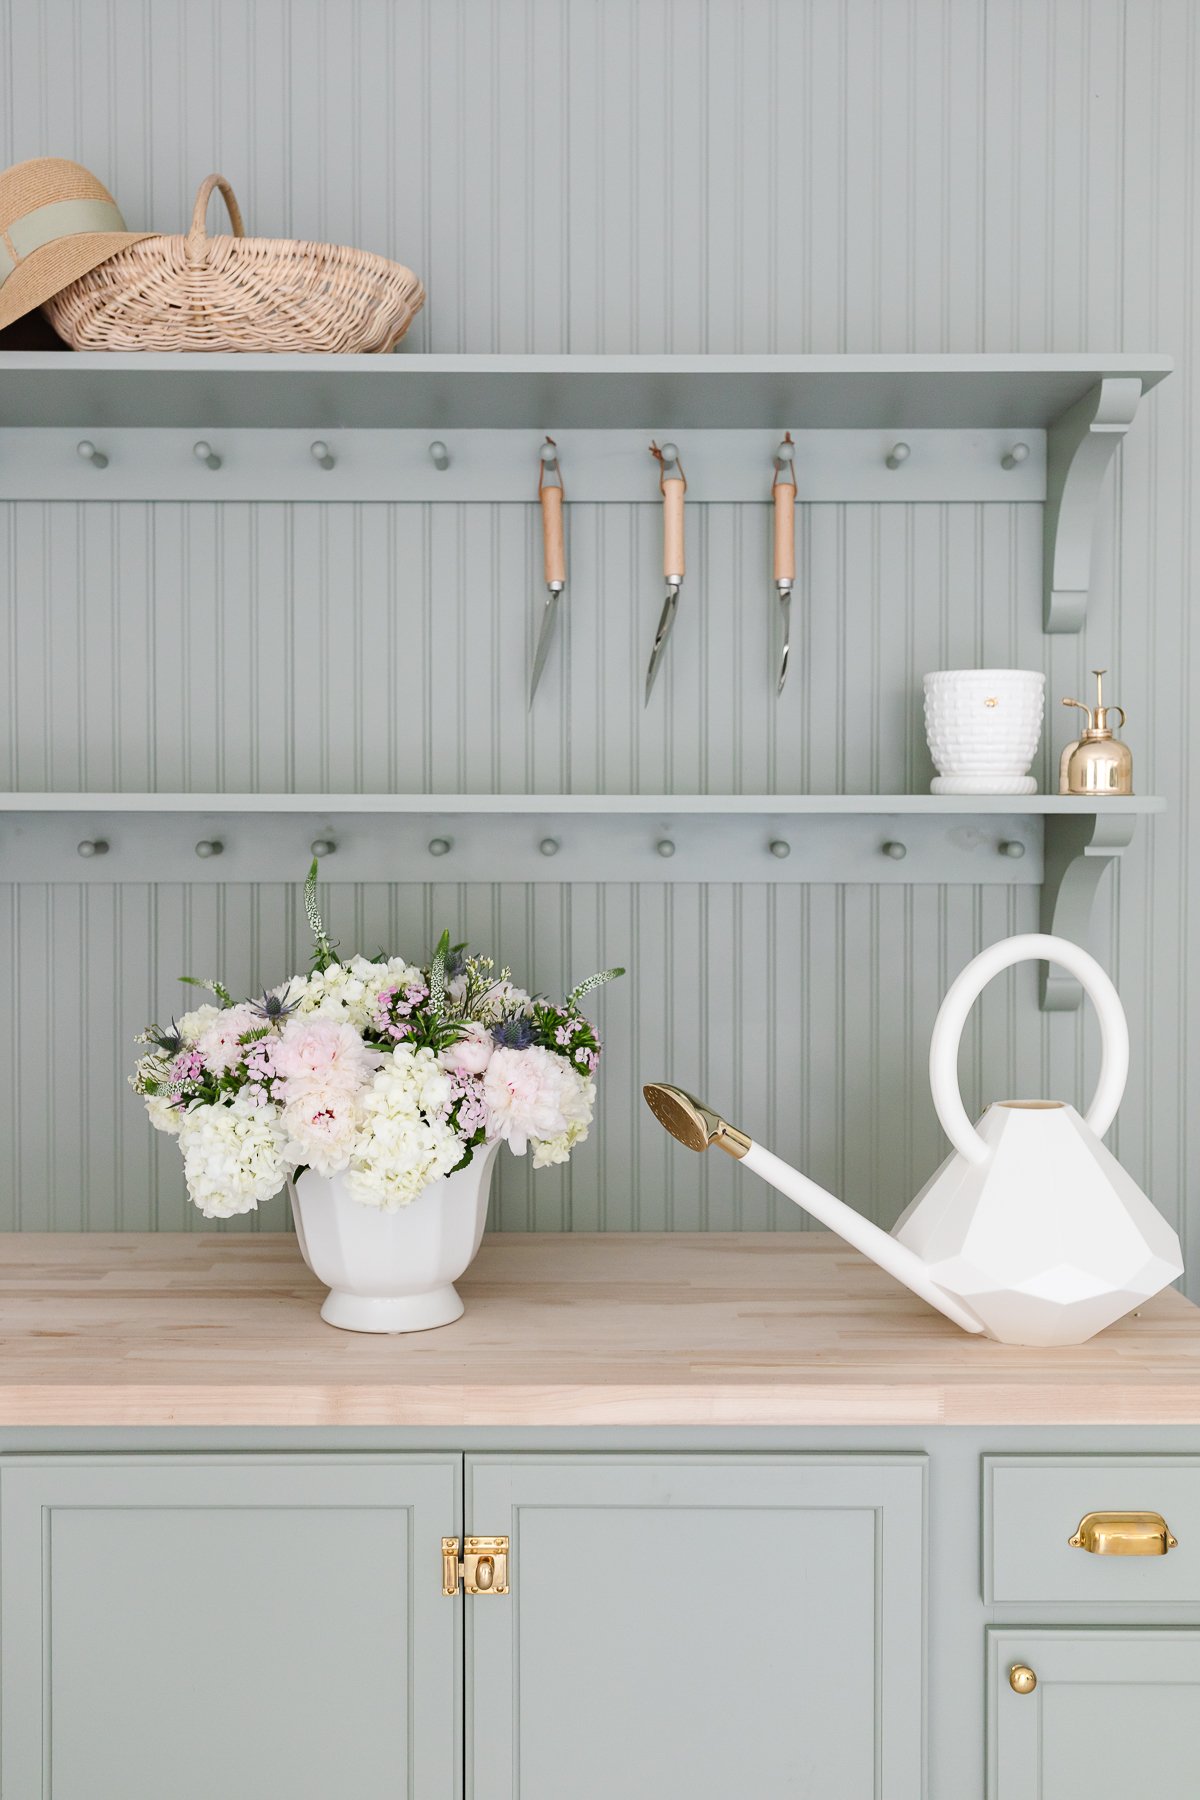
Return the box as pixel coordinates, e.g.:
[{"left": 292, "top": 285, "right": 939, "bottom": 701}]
[{"left": 925, "top": 670, "right": 1045, "bottom": 794}]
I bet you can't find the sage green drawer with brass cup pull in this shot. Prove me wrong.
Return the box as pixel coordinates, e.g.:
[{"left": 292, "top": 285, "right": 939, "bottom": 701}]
[{"left": 982, "top": 1456, "right": 1200, "bottom": 1611}]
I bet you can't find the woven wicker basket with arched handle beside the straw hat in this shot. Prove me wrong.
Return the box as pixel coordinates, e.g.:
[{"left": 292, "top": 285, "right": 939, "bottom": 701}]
[{"left": 45, "top": 175, "right": 425, "bottom": 351}]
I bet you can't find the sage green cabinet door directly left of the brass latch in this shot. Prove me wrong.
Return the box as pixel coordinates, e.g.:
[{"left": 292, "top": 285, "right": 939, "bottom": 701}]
[{"left": 0, "top": 1454, "right": 461, "bottom": 1800}]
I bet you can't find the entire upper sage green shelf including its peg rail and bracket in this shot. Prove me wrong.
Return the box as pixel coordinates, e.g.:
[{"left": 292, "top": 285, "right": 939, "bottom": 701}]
[{"left": 0, "top": 351, "right": 1171, "bottom": 632}]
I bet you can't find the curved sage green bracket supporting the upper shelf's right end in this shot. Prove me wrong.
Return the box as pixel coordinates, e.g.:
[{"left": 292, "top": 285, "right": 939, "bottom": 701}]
[{"left": 1043, "top": 374, "right": 1142, "bottom": 632}]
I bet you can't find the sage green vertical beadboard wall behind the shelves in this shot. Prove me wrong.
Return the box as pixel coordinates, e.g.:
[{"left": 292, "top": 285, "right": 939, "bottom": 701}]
[{"left": 0, "top": 0, "right": 1200, "bottom": 1291}]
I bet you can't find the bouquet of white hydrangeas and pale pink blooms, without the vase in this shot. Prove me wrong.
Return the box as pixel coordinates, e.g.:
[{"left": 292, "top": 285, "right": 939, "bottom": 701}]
[{"left": 130, "top": 862, "right": 624, "bottom": 1219}]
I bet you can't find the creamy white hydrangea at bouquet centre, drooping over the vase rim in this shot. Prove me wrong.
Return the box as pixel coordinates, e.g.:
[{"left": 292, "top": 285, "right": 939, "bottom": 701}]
[{"left": 345, "top": 1044, "right": 462, "bottom": 1213}]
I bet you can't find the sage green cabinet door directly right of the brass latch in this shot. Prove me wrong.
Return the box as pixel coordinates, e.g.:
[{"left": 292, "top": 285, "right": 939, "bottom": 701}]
[{"left": 466, "top": 1454, "right": 925, "bottom": 1800}]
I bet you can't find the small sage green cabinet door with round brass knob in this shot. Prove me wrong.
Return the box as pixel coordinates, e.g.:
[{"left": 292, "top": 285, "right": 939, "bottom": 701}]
[{"left": 988, "top": 1625, "right": 1200, "bottom": 1800}]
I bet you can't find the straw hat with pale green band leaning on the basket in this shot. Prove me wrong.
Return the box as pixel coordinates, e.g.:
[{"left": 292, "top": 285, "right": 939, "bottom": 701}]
[{"left": 0, "top": 157, "right": 158, "bottom": 328}]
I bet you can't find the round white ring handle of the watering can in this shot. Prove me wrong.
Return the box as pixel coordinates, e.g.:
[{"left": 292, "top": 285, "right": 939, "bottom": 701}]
[{"left": 928, "top": 931, "right": 1130, "bottom": 1163}]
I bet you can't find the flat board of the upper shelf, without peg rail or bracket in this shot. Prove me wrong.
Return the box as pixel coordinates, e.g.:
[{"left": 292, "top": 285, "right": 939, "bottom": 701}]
[{"left": 0, "top": 351, "right": 1173, "bottom": 432}]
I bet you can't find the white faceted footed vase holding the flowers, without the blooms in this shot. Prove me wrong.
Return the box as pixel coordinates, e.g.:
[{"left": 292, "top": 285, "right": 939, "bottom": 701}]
[{"left": 288, "top": 1143, "right": 498, "bottom": 1332}]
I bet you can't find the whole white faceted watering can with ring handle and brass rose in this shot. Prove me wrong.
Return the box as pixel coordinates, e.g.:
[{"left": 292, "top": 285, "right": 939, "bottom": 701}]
[{"left": 644, "top": 932, "right": 1184, "bottom": 1345}]
